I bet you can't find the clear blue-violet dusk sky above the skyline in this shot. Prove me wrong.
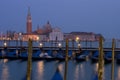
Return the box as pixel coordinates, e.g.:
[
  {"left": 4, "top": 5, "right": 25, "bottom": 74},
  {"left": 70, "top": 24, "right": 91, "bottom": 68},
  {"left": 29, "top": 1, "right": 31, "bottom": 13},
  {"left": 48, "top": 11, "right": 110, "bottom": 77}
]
[{"left": 0, "top": 0, "right": 120, "bottom": 38}]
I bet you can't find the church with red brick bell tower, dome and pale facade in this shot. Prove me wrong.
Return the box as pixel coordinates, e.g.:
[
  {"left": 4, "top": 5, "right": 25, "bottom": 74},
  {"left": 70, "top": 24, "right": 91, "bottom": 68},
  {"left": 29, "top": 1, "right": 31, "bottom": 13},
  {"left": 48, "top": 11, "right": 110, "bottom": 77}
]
[{"left": 22, "top": 8, "right": 63, "bottom": 41}]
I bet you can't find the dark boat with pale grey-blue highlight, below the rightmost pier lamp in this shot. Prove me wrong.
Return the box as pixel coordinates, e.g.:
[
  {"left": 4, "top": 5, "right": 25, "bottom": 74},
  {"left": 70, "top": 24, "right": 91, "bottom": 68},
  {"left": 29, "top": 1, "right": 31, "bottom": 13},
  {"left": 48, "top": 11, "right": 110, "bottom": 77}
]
[{"left": 75, "top": 50, "right": 90, "bottom": 61}]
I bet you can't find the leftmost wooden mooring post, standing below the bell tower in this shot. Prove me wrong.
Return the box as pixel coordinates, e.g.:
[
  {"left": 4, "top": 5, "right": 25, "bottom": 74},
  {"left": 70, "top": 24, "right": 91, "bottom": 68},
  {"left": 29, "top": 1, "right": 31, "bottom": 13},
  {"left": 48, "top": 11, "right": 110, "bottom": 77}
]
[{"left": 27, "top": 39, "right": 32, "bottom": 80}]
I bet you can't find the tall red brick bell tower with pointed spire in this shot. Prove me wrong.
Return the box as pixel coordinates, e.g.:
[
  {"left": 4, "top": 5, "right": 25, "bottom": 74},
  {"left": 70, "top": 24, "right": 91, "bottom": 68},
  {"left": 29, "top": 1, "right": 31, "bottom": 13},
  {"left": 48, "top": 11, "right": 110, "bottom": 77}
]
[{"left": 26, "top": 7, "right": 32, "bottom": 34}]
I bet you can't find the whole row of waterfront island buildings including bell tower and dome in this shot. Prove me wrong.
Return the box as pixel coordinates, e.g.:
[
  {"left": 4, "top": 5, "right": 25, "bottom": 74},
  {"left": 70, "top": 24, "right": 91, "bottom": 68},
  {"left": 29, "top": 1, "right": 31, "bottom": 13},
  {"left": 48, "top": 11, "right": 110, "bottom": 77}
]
[{"left": 12, "top": 8, "right": 102, "bottom": 41}]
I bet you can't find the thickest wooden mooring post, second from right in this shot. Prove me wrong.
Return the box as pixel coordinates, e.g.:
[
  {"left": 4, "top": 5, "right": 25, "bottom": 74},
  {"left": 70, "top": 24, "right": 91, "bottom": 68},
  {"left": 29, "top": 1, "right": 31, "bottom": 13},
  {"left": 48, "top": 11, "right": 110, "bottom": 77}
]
[{"left": 98, "top": 37, "right": 104, "bottom": 80}]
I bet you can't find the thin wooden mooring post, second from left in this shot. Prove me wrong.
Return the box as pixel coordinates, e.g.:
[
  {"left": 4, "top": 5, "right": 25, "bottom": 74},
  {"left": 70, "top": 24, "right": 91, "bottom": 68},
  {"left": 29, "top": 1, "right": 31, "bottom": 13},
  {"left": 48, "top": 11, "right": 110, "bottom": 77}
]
[{"left": 64, "top": 39, "right": 68, "bottom": 80}]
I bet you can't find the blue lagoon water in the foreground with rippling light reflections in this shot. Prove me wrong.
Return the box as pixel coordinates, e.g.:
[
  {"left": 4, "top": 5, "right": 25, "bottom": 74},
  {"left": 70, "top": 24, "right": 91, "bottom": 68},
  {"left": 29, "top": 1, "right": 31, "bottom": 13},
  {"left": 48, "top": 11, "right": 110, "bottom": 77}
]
[{"left": 0, "top": 59, "right": 120, "bottom": 80}]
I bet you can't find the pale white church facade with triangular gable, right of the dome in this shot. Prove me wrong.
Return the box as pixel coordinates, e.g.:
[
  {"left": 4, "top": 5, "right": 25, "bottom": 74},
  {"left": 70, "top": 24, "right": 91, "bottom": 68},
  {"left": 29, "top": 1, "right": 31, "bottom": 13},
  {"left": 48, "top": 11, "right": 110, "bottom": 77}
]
[{"left": 49, "top": 28, "right": 64, "bottom": 41}]
